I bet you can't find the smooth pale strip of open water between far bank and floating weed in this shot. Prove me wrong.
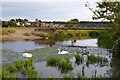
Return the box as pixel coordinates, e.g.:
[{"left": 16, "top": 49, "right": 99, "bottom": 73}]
[{"left": 0, "top": 39, "right": 97, "bottom": 52}]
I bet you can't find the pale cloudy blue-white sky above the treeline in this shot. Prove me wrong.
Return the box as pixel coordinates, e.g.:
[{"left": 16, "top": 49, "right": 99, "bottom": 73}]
[{"left": 0, "top": 0, "right": 102, "bottom": 21}]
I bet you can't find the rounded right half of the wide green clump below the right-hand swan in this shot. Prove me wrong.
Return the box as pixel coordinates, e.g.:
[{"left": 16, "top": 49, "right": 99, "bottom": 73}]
[{"left": 58, "top": 59, "right": 73, "bottom": 72}]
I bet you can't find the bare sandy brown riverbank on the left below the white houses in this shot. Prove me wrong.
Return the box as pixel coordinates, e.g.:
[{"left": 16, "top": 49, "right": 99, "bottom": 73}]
[{"left": 0, "top": 27, "right": 41, "bottom": 40}]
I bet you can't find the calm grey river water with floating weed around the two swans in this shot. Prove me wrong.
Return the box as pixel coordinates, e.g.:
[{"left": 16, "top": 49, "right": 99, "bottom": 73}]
[{"left": 2, "top": 39, "right": 111, "bottom": 78}]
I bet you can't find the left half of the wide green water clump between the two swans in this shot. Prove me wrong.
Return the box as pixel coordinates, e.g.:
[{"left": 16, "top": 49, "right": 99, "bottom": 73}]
[{"left": 47, "top": 56, "right": 60, "bottom": 66}]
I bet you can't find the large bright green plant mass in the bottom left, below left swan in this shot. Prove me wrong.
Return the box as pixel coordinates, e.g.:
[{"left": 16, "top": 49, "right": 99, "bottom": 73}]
[{"left": 2, "top": 58, "right": 39, "bottom": 80}]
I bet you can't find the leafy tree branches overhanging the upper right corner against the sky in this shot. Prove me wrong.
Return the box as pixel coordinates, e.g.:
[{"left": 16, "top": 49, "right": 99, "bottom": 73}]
[{"left": 85, "top": 0, "right": 120, "bottom": 36}]
